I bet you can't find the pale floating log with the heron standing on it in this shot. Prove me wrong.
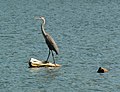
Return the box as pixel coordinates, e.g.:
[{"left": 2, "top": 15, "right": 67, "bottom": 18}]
[{"left": 29, "top": 58, "right": 61, "bottom": 67}]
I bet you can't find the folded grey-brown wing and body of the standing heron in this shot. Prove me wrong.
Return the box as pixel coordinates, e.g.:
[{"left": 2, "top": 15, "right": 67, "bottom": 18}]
[{"left": 45, "top": 33, "right": 59, "bottom": 54}]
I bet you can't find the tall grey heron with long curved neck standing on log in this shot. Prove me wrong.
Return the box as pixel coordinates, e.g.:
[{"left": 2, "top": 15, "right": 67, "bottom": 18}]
[{"left": 35, "top": 17, "right": 59, "bottom": 64}]
